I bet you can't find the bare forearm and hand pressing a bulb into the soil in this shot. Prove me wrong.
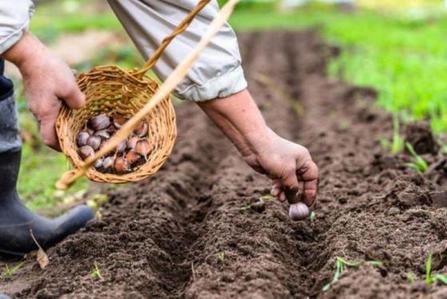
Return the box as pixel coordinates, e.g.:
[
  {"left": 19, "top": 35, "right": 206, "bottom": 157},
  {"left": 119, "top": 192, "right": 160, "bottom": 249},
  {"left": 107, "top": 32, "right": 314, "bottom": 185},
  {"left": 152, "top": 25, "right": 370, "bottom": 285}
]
[{"left": 199, "top": 90, "right": 318, "bottom": 206}]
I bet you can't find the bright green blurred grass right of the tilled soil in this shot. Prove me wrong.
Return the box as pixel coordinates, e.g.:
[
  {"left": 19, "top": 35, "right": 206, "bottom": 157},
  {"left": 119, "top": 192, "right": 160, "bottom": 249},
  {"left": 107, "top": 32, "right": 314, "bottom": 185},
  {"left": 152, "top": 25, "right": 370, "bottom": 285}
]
[{"left": 231, "top": 6, "right": 447, "bottom": 133}]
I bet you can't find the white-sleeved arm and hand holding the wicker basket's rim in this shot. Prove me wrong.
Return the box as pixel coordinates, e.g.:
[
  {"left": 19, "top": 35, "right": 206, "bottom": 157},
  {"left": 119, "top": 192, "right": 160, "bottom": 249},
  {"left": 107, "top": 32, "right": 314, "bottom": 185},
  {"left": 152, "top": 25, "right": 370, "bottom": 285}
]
[{"left": 0, "top": 0, "right": 85, "bottom": 149}]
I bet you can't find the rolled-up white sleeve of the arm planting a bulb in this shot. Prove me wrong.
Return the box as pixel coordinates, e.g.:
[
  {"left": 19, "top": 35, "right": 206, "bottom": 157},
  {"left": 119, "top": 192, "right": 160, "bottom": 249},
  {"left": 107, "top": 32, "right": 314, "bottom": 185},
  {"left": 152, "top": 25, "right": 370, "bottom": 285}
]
[{"left": 108, "top": 0, "right": 247, "bottom": 101}]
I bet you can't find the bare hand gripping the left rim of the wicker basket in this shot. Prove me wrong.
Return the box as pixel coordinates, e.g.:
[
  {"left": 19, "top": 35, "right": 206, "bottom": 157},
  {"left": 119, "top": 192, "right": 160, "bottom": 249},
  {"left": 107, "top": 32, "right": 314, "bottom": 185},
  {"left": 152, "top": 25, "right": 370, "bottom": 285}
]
[{"left": 2, "top": 33, "right": 85, "bottom": 150}]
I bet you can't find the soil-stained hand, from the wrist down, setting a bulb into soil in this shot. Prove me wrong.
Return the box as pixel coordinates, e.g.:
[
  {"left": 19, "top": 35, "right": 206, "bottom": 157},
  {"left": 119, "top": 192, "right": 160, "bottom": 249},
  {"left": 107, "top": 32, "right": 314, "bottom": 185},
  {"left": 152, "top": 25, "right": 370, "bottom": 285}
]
[{"left": 244, "top": 130, "right": 318, "bottom": 206}]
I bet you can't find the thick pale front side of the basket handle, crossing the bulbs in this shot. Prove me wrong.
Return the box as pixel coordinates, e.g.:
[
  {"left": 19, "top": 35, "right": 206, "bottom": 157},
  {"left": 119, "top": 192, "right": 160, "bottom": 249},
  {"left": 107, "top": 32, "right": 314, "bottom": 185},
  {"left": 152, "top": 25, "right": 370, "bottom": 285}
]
[{"left": 56, "top": 0, "right": 243, "bottom": 189}]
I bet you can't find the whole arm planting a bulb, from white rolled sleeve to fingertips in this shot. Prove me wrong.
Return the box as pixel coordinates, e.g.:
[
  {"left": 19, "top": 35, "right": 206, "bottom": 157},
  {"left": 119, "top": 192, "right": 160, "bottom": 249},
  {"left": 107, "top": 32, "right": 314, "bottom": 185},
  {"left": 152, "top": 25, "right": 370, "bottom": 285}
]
[{"left": 108, "top": 0, "right": 318, "bottom": 211}]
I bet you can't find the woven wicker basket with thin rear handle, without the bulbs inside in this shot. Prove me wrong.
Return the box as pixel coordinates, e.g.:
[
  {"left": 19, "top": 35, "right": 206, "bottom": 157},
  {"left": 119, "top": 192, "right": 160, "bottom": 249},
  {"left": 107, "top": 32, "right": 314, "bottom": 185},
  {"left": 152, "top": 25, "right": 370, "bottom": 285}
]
[{"left": 56, "top": 0, "right": 210, "bottom": 183}]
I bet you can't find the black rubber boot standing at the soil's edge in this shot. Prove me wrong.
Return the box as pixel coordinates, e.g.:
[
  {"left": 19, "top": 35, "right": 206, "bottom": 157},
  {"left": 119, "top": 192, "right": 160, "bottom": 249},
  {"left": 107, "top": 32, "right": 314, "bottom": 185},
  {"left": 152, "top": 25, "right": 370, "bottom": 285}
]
[{"left": 0, "top": 151, "right": 94, "bottom": 258}]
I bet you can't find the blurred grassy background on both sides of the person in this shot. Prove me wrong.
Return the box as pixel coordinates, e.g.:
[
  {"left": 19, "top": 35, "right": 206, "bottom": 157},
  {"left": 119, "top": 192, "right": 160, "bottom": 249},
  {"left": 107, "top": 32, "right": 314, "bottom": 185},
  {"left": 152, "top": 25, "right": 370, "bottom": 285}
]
[{"left": 8, "top": 0, "right": 447, "bottom": 209}]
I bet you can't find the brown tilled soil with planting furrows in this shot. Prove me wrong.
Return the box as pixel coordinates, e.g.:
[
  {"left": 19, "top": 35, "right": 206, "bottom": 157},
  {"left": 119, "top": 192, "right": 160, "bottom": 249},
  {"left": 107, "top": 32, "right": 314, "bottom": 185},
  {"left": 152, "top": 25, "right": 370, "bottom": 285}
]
[{"left": 0, "top": 32, "right": 447, "bottom": 298}]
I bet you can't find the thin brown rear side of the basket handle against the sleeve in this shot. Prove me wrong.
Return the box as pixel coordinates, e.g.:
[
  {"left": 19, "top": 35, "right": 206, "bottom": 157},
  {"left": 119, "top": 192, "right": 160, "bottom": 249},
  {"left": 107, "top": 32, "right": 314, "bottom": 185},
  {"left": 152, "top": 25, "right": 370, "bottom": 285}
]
[{"left": 133, "top": 0, "right": 210, "bottom": 78}]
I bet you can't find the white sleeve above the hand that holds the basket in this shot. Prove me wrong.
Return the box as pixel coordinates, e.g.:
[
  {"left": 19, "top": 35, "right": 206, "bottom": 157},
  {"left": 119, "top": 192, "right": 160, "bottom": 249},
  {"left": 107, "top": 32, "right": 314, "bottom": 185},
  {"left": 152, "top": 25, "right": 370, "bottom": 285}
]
[{"left": 0, "top": 0, "right": 34, "bottom": 54}]
